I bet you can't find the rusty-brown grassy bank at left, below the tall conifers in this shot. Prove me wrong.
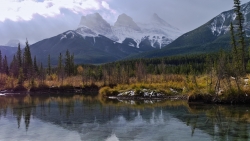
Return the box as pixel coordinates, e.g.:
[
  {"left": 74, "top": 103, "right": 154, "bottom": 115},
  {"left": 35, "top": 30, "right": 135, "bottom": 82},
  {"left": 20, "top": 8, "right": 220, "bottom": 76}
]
[{"left": 0, "top": 74, "right": 103, "bottom": 93}]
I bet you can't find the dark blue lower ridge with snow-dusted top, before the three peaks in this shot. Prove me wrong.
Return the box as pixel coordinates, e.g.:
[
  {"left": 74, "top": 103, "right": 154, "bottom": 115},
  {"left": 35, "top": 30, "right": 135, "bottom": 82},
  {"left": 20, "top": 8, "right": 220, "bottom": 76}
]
[{"left": 30, "top": 26, "right": 154, "bottom": 65}]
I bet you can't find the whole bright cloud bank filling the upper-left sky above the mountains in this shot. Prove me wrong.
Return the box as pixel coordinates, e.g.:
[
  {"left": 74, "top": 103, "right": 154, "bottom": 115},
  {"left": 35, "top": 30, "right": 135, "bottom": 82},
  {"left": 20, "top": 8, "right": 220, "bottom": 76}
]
[{"left": 0, "top": 0, "right": 117, "bottom": 45}]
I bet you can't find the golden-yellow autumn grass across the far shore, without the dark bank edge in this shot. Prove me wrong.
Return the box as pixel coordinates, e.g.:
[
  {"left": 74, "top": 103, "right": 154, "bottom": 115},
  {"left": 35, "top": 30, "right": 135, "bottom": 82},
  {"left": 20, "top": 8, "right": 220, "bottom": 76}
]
[{"left": 0, "top": 73, "right": 250, "bottom": 98}]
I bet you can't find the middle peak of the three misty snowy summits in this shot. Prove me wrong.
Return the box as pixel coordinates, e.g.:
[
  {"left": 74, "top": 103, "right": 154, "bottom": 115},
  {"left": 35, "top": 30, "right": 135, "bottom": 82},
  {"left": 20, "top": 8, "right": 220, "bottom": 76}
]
[{"left": 114, "top": 14, "right": 141, "bottom": 31}]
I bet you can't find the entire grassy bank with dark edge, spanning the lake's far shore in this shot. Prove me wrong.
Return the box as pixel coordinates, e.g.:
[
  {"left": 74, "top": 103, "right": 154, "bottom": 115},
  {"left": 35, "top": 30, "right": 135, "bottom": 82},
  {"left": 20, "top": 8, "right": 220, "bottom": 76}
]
[{"left": 0, "top": 72, "right": 250, "bottom": 103}]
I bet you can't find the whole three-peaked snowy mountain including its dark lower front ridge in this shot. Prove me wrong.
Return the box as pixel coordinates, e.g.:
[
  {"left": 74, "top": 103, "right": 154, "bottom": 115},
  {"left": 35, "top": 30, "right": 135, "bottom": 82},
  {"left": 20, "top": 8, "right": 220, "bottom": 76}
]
[{"left": 20, "top": 13, "right": 181, "bottom": 65}]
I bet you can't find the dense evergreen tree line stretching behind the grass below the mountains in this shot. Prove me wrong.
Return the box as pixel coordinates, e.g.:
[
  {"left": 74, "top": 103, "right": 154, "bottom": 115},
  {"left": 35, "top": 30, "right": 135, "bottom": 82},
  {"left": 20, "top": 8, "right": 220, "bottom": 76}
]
[{"left": 0, "top": 42, "right": 250, "bottom": 88}]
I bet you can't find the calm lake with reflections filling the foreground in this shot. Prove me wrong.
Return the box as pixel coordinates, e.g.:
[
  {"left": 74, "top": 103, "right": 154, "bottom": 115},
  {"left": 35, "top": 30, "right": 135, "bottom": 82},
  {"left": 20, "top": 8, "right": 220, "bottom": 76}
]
[{"left": 0, "top": 95, "right": 250, "bottom": 141}]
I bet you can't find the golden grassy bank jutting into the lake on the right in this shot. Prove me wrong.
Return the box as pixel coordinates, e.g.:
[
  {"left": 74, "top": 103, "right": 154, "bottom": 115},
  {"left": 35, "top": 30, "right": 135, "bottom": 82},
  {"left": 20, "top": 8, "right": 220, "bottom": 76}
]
[{"left": 99, "top": 75, "right": 250, "bottom": 104}]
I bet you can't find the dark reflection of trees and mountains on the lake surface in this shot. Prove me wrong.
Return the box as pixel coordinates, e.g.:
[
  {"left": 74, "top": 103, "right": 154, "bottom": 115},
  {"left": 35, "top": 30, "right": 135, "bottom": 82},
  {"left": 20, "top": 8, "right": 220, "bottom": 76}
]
[{"left": 0, "top": 95, "right": 250, "bottom": 141}]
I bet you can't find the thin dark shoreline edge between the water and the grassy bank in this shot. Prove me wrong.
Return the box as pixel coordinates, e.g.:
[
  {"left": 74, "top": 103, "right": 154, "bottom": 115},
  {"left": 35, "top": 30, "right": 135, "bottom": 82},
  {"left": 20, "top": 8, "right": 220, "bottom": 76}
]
[{"left": 0, "top": 87, "right": 250, "bottom": 105}]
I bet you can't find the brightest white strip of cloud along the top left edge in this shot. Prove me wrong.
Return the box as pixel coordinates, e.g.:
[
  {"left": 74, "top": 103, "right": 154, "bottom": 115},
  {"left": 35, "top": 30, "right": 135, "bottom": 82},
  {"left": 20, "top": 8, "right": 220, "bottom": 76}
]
[{"left": 0, "top": 0, "right": 115, "bottom": 21}]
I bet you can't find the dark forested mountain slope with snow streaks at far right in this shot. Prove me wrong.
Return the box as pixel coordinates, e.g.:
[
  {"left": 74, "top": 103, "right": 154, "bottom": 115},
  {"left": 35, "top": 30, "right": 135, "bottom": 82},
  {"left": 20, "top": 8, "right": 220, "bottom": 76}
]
[{"left": 127, "top": 2, "right": 250, "bottom": 57}]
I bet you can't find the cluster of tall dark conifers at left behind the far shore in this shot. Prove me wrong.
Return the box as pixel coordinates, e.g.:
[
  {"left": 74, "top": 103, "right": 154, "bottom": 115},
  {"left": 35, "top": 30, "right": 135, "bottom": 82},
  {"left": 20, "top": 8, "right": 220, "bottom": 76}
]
[{"left": 0, "top": 41, "right": 75, "bottom": 85}]
